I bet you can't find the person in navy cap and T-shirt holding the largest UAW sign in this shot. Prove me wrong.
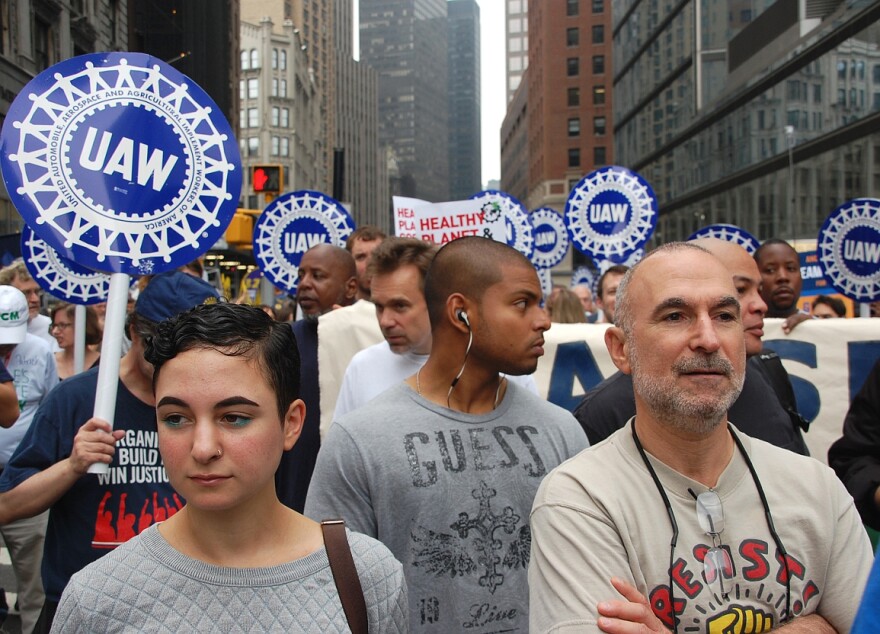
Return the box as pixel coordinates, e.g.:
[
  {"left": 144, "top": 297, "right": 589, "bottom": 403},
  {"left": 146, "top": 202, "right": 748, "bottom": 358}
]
[{"left": 0, "top": 272, "right": 217, "bottom": 632}]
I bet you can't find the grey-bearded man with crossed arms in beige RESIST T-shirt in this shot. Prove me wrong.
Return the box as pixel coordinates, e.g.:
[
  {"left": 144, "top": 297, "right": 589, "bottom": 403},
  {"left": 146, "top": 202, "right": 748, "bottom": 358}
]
[{"left": 529, "top": 243, "right": 872, "bottom": 634}]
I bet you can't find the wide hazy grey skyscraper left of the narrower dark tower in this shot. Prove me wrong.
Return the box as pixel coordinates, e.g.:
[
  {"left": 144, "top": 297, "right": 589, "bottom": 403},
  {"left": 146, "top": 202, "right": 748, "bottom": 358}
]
[{"left": 360, "top": 0, "right": 449, "bottom": 201}]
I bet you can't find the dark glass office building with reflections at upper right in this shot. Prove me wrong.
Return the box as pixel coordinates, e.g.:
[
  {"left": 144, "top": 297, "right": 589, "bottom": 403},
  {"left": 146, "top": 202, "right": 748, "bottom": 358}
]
[{"left": 613, "top": 0, "right": 880, "bottom": 244}]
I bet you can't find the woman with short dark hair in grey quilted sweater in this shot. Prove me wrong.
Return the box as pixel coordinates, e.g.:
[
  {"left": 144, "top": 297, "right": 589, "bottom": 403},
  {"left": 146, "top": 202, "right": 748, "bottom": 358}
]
[{"left": 55, "top": 303, "right": 407, "bottom": 634}]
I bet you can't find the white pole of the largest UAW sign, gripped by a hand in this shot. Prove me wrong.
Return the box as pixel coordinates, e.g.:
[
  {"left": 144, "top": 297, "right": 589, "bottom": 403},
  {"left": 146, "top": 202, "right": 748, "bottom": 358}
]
[{"left": 89, "top": 273, "right": 131, "bottom": 473}]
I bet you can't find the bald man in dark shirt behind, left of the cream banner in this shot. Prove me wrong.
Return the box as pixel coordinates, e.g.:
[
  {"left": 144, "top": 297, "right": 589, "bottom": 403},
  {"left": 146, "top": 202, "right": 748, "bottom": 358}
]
[{"left": 275, "top": 239, "right": 357, "bottom": 519}]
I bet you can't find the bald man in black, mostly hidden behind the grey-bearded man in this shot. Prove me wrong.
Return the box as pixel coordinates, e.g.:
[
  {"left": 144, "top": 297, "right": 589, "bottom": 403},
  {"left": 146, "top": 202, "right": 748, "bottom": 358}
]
[{"left": 574, "top": 238, "right": 808, "bottom": 455}]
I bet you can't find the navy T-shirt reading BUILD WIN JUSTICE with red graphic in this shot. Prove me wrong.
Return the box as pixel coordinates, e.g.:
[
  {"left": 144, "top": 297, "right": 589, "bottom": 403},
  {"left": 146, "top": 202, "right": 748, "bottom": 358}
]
[{"left": 0, "top": 368, "right": 184, "bottom": 602}]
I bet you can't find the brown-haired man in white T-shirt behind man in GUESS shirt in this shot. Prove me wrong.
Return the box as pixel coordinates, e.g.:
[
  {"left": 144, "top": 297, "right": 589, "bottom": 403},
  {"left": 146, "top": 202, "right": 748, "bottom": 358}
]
[{"left": 334, "top": 237, "right": 538, "bottom": 419}]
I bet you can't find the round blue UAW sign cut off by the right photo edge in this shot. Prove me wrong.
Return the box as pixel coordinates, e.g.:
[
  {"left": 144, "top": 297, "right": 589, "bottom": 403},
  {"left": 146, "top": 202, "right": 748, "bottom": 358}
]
[{"left": 817, "top": 198, "right": 880, "bottom": 302}]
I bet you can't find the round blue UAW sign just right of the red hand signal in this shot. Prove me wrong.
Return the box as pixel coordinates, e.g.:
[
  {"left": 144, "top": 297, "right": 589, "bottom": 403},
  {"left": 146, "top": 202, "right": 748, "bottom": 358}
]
[{"left": 253, "top": 189, "right": 354, "bottom": 293}]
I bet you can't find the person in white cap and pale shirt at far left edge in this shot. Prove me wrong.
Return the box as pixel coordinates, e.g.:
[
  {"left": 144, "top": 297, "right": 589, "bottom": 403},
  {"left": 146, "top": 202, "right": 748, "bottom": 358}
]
[{"left": 0, "top": 286, "right": 58, "bottom": 632}]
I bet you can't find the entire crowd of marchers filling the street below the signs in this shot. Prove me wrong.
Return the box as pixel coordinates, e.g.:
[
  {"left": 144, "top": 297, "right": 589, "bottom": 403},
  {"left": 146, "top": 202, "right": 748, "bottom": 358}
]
[{"left": 0, "top": 227, "right": 880, "bottom": 634}]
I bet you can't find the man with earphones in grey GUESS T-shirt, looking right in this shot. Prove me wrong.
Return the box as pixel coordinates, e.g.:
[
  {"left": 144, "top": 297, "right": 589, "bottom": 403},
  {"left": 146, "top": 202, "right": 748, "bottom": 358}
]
[{"left": 306, "top": 237, "right": 587, "bottom": 633}]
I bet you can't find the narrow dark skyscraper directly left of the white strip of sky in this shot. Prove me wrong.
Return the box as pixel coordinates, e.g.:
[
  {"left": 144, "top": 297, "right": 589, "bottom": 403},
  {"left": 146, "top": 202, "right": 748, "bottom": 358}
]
[{"left": 448, "top": 0, "right": 482, "bottom": 200}]
